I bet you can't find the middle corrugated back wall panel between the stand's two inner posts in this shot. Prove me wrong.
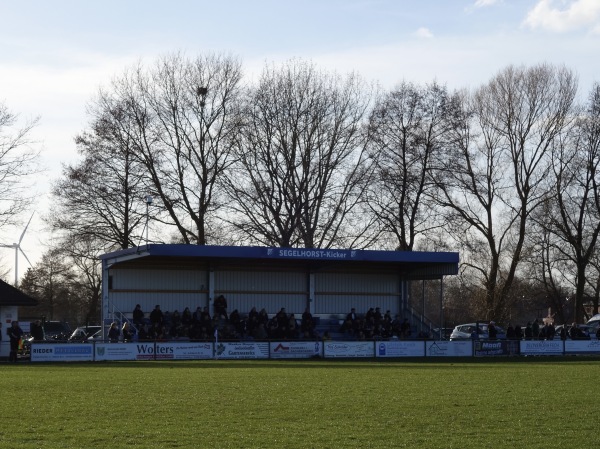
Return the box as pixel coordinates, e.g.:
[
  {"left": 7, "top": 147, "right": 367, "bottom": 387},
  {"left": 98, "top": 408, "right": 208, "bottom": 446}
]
[{"left": 215, "top": 271, "right": 308, "bottom": 314}]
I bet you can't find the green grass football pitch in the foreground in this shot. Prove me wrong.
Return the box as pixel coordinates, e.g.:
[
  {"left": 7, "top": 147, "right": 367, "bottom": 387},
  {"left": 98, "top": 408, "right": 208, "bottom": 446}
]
[{"left": 0, "top": 357, "right": 600, "bottom": 449}]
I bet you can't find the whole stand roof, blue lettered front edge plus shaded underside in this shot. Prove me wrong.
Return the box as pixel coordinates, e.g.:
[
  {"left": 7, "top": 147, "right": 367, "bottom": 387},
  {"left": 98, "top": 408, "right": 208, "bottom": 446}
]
[{"left": 100, "top": 244, "right": 459, "bottom": 279}]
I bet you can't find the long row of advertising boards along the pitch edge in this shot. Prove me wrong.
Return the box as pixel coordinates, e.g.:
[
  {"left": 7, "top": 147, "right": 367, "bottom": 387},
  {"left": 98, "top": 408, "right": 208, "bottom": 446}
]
[{"left": 30, "top": 340, "right": 600, "bottom": 362}]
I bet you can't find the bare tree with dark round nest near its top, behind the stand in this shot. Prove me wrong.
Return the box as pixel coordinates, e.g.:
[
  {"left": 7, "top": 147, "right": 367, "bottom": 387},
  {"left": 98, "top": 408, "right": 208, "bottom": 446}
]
[{"left": 111, "top": 54, "right": 242, "bottom": 245}]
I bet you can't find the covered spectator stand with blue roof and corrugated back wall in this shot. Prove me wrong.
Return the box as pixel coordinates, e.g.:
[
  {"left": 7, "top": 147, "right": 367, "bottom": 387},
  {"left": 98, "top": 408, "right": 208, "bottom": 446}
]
[{"left": 100, "top": 244, "right": 459, "bottom": 330}]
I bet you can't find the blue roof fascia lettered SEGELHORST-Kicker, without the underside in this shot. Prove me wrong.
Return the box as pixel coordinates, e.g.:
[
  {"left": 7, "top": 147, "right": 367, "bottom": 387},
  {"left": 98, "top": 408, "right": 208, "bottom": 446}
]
[{"left": 100, "top": 244, "right": 459, "bottom": 264}]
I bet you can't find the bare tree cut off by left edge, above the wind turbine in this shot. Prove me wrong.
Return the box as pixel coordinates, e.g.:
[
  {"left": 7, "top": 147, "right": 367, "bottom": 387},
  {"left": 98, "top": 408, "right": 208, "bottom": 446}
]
[{"left": 0, "top": 103, "right": 38, "bottom": 229}]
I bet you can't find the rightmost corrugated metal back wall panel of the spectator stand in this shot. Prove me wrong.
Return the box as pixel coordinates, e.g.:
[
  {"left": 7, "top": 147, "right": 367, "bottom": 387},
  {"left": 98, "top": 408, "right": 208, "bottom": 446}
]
[{"left": 315, "top": 273, "right": 400, "bottom": 315}]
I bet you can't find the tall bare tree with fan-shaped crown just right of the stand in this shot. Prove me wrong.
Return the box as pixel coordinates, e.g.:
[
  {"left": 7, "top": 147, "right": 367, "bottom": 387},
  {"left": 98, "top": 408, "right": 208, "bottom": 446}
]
[{"left": 435, "top": 65, "right": 577, "bottom": 319}]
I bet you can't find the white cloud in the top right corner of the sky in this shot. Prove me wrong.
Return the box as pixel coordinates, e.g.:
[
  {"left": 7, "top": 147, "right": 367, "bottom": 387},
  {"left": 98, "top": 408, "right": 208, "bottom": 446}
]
[{"left": 523, "top": 0, "right": 600, "bottom": 33}]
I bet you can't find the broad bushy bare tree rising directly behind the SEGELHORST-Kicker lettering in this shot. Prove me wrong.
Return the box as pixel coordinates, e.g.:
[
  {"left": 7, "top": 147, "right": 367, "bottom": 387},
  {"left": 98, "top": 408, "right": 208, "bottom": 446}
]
[{"left": 227, "top": 61, "right": 370, "bottom": 248}]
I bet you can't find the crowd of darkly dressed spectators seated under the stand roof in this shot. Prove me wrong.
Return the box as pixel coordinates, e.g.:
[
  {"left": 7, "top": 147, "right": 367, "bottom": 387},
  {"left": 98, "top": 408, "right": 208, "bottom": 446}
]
[{"left": 118, "top": 295, "right": 418, "bottom": 341}]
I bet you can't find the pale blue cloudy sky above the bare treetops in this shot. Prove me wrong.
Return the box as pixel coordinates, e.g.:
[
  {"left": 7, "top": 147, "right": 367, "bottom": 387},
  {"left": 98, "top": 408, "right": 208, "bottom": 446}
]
[{"left": 0, "top": 0, "right": 600, "bottom": 280}]
